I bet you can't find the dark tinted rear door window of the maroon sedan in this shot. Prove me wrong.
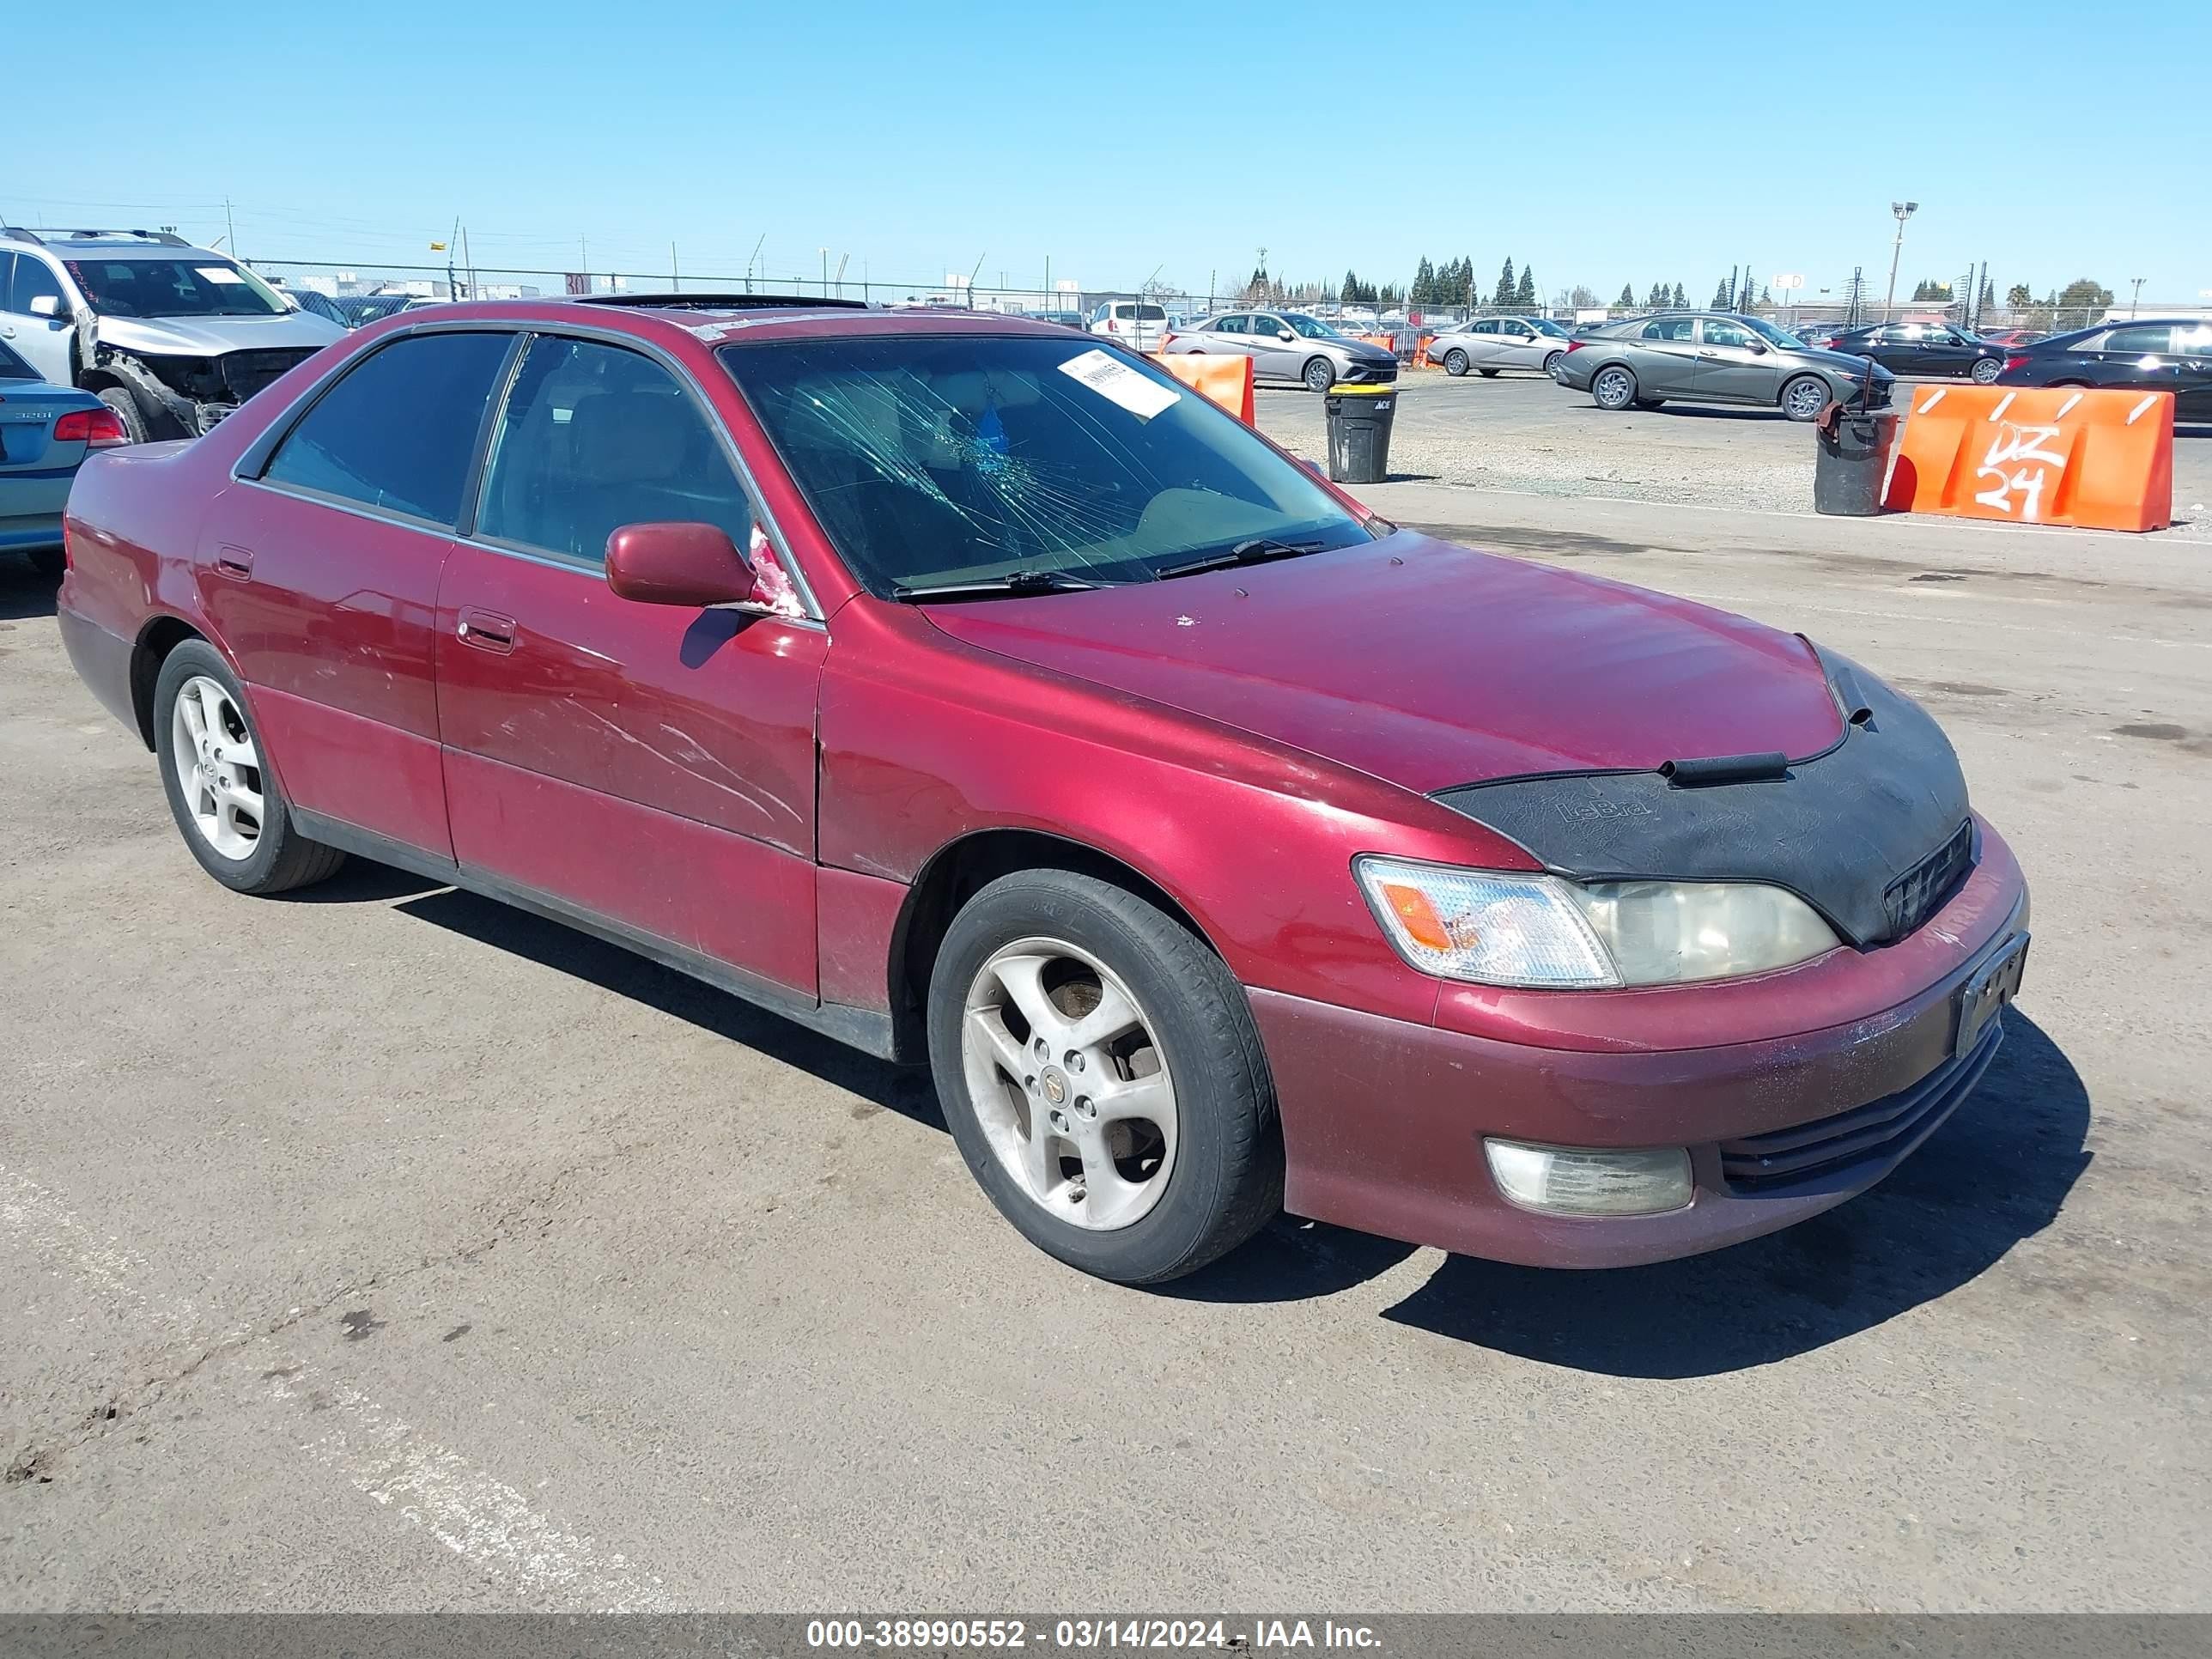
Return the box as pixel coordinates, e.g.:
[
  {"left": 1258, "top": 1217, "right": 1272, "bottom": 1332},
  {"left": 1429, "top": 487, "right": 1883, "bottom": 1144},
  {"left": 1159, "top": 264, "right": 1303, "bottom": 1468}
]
[{"left": 261, "top": 334, "right": 515, "bottom": 529}]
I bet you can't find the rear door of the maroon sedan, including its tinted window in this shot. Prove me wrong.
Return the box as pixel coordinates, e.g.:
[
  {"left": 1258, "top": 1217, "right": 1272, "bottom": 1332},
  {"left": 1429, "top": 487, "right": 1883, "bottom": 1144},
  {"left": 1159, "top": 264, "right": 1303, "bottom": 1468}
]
[{"left": 222, "top": 330, "right": 518, "bottom": 858}]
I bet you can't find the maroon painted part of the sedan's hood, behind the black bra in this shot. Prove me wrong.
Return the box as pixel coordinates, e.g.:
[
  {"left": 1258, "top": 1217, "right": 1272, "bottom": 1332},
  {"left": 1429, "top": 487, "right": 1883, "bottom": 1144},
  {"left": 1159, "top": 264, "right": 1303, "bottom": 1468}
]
[{"left": 927, "top": 531, "right": 1843, "bottom": 794}]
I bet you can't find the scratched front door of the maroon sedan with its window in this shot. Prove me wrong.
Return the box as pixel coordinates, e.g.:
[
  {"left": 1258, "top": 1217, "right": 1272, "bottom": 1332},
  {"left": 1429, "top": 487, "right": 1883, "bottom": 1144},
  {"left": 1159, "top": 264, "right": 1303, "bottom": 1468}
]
[{"left": 438, "top": 334, "right": 827, "bottom": 998}]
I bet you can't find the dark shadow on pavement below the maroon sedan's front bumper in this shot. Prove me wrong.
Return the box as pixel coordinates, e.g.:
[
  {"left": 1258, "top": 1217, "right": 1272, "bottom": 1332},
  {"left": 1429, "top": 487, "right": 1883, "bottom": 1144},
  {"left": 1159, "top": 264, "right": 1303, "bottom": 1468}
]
[{"left": 1385, "top": 1009, "right": 2090, "bottom": 1380}]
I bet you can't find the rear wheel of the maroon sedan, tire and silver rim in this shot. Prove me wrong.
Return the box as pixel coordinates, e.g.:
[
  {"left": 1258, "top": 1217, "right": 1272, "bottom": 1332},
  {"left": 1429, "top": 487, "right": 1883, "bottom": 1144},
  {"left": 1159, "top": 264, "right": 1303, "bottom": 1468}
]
[{"left": 153, "top": 639, "right": 345, "bottom": 896}]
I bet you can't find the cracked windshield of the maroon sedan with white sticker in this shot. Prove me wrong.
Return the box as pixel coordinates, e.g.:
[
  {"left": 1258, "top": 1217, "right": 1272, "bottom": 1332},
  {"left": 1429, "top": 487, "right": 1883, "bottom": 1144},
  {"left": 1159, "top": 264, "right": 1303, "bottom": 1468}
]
[{"left": 721, "top": 334, "right": 1371, "bottom": 598}]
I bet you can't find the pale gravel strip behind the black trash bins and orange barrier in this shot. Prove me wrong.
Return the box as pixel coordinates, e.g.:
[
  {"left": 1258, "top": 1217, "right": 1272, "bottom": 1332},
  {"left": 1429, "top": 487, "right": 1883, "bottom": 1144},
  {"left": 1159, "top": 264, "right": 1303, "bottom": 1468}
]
[{"left": 1259, "top": 369, "right": 2212, "bottom": 540}]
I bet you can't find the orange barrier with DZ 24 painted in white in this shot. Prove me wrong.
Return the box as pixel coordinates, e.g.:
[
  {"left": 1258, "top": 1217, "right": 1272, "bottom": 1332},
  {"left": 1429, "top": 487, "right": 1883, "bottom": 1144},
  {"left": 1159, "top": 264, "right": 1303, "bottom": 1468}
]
[{"left": 1882, "top": 385, "right": 2174, "bottom": 531}]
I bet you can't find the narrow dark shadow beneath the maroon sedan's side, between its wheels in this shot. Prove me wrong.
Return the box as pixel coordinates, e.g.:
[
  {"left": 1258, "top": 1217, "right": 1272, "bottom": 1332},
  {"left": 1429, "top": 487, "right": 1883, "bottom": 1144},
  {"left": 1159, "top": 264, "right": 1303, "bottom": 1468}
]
[{"left": 389, "top": 889, "right": 945, "bottom": 1130}]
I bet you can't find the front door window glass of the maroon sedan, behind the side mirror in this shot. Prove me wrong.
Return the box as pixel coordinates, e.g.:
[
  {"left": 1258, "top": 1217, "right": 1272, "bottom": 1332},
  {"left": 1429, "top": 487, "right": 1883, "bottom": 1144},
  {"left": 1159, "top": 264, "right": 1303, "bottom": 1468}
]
[{"left": 476, "top": 337, "right": 752, "bottom": 564}]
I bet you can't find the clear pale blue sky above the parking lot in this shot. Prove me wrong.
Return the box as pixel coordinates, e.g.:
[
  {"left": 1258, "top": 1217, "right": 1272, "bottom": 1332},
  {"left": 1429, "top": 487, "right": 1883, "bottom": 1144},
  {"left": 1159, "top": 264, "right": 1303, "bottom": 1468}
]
[{"left": 0, "top": 0, "right": 2212, "bottom": 303}]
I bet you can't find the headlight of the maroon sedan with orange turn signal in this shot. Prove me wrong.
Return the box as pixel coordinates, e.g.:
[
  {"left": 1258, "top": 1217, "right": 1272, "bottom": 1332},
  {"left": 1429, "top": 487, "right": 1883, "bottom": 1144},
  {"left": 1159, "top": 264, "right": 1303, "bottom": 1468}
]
[{"left": 1354, "top": 856, "right": 1840, "bottom": 991}]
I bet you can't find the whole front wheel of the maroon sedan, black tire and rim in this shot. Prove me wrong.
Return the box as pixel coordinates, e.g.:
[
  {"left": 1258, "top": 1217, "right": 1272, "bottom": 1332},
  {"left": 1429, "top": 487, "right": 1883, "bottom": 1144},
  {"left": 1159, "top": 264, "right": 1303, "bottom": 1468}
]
[{"left": 929, "top": 869, "right": 1283, "bottom": 1285}]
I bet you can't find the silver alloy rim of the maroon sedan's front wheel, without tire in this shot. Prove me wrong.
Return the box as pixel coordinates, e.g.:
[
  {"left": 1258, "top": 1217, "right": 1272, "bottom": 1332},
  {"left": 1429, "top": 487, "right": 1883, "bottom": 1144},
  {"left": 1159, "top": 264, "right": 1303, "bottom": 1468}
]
[{"left": 960, "top": 938, "right": 1176, "bottom": 1232}]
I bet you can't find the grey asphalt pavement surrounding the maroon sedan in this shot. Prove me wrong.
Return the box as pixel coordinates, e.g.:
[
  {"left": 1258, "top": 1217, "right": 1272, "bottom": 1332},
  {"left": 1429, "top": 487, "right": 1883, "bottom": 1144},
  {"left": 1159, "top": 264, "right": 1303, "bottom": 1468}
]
[{"left": 0, "top": 424, "right": 2212, "bottom": 1613}]
